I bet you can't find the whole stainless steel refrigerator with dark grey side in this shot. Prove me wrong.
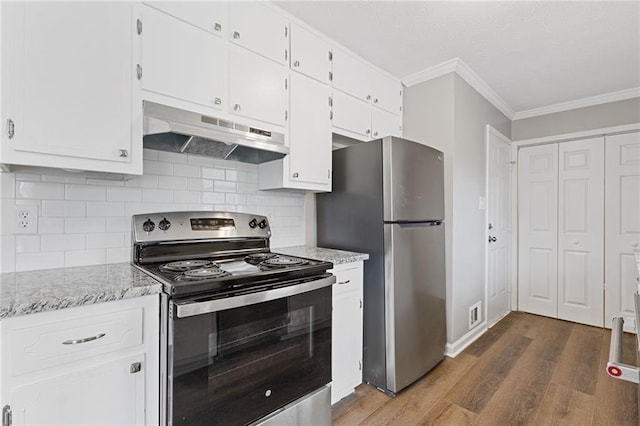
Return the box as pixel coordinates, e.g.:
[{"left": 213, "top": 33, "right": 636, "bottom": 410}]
[{"left": 316, "top": 137, "right": 446, "bottom": 395}]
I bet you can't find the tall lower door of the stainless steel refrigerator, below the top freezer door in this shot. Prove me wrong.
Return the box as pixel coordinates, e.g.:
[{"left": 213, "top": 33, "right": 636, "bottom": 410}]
[{"left": 384, "top": 224, "right": 446, "bottom": 393}]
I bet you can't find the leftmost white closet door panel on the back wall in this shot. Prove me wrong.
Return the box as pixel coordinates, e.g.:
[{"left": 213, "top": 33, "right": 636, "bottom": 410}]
[{"left": 518, "top": 144, "right": 558, "bottom": 317}]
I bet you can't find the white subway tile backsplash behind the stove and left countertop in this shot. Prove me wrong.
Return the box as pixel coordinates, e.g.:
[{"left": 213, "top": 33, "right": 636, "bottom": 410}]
[{"left": 0, "top": 150, "right": 308, "bottom": 272}]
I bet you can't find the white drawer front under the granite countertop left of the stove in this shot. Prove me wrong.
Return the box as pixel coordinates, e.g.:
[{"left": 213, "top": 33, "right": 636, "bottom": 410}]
[{"left": 3, "top": 308, "right": 143, "bottom": 376}]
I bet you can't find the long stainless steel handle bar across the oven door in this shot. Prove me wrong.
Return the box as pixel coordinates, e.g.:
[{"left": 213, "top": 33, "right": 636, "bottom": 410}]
[{"left": 172, "top": 275, "right": 336, "bottom": 318}]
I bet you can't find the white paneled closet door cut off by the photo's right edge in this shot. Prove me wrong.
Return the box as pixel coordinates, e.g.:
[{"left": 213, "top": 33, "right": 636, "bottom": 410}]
[{"left": 605, "top": 133, "right": 640, "bottom": 327}]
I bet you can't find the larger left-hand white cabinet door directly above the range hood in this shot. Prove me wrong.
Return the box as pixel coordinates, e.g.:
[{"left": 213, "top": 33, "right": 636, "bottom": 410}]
[{"left": 141, "top": 3, "right": 225, "bottom": 109}]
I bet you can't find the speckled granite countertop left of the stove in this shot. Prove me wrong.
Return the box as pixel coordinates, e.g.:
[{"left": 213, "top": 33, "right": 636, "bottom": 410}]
[{"left": 0, "top": 263, "right": 162, "bottom": 319}]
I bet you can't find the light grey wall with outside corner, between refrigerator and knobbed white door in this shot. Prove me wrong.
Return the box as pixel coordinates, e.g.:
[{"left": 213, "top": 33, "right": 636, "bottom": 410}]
[{"left": 403, "top": 73, "right": 511, "bottom": 343}]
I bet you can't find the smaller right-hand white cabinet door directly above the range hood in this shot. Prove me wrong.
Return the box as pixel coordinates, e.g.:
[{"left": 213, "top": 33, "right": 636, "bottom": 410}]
[{"left": 229, "top": 48, "right": 288, "bottom": 126}]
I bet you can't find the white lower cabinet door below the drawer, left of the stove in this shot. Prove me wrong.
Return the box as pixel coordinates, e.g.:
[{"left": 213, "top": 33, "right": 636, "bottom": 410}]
[{"left": 6, "top": 354, "right": 146, "bottom": 426}]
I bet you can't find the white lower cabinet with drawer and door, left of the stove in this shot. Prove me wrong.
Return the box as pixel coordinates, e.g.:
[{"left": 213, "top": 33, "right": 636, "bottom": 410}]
[{"left": 0, "top": 295, "right": 159, "bottom": 426}]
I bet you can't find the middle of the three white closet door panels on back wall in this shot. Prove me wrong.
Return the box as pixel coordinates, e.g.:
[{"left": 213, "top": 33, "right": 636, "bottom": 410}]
[{"left": 558, "top": 137, "right": 604, "bottom": 327}]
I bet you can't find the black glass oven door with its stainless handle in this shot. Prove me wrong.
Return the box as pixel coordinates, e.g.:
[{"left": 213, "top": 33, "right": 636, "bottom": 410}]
[{"left": 166, "top": 275, "right": 335, "bottom": 425}]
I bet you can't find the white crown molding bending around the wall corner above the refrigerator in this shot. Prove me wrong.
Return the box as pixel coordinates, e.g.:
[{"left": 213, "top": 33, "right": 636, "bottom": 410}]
[{"left": 401, "top": 58, "right": 514, "bottom": 120}]
